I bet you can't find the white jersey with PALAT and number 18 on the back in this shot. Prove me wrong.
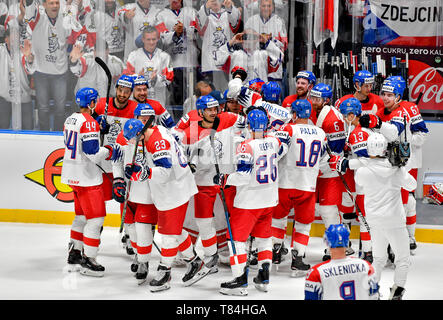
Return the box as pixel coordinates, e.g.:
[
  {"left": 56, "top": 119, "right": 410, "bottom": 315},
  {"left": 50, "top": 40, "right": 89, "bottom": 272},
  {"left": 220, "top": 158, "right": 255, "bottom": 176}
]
[{"left": 274, "top": 123, "right": 327, "bottom": 192}]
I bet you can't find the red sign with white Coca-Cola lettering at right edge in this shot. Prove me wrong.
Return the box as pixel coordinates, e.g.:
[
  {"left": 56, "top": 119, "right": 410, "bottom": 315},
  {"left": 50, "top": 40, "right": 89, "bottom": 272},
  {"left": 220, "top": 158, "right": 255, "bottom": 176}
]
[{"left": 409, "top": 60, "right": 443, "bottom": 111}]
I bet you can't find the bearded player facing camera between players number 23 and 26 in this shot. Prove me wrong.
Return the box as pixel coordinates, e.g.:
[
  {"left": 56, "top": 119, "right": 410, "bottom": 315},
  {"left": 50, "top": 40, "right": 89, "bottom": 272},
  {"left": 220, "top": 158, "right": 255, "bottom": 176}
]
[{"left": 183, "top": 95, "right": 245, "bottom": 281}]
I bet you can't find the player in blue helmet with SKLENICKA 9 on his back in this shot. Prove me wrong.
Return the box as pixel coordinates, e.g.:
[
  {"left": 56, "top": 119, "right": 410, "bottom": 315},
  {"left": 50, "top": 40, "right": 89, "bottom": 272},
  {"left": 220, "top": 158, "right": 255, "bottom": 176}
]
[{"left": 305, "top": 224, "right": 380, "bottom": 300}]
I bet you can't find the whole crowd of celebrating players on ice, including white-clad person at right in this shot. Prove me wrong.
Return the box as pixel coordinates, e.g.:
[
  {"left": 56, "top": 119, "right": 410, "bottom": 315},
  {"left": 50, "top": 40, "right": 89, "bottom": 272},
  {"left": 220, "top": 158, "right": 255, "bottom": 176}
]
[{"left": 62, "top": 63, "right": 429, "bottom": 299}]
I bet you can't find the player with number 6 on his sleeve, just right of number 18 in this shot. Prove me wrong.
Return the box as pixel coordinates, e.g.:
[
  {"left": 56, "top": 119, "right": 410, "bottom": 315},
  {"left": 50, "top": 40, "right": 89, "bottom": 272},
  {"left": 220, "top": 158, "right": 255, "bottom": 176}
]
[{"left": 310, "top": 83, "right": 353, "bottom": 260}]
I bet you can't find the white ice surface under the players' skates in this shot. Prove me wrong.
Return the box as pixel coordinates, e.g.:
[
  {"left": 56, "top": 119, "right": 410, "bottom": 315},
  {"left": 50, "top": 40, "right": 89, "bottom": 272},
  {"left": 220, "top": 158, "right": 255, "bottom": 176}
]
[{"left": 0, "top": 223, "right": 443, "bottom": 302}]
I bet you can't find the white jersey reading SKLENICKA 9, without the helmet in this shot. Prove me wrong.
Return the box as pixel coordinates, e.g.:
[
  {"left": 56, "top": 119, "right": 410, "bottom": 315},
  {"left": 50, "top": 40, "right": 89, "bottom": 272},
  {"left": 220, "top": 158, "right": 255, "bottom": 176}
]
[{"left": 305, "top": 257, "right": 374, "bottom": 300}]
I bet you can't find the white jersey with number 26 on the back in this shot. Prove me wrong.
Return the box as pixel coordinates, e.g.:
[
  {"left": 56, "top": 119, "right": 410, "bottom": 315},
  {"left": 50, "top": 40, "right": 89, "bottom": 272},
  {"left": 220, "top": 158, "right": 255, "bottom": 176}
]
[{"left": 226, "top": 136, "right": 287, "bottom": 209}]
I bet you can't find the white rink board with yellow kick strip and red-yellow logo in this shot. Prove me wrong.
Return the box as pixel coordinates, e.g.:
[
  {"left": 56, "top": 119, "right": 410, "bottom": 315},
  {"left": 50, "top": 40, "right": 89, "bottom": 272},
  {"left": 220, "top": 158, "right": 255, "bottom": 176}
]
[{"left": 0, "top": 133, "right": 443, "bottom": 243}]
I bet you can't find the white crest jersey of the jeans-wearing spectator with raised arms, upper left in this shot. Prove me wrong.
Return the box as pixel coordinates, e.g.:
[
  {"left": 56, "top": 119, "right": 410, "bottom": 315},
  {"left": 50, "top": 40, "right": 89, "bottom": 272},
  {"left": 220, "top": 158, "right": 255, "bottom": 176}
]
[{"left": 25, "top": 1, "right": 82, "bottom": 74}]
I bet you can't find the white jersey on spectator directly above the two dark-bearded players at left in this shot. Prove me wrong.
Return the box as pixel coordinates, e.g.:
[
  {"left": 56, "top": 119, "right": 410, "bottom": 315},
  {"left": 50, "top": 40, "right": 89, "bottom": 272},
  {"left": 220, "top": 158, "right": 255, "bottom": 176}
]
[{"left": 123, "top": 48, "right": 174, "bottom": 106}]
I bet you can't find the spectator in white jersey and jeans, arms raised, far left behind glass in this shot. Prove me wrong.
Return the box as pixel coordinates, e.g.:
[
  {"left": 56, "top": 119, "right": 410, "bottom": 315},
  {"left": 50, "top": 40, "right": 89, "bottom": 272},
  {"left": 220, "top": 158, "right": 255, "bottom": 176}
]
[{"left": 25, "top": 0, "right": 82, "bottom": 131}]
